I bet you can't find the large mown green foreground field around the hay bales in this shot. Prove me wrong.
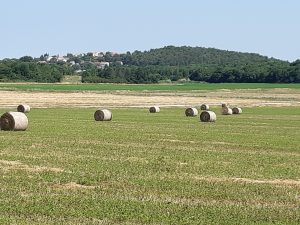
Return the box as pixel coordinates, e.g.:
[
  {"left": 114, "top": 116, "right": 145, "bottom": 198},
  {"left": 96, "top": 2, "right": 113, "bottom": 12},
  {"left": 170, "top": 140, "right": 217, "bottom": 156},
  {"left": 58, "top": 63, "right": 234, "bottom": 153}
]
[{"left": 0, "top": 107, "right": 300, "bottom": 224}]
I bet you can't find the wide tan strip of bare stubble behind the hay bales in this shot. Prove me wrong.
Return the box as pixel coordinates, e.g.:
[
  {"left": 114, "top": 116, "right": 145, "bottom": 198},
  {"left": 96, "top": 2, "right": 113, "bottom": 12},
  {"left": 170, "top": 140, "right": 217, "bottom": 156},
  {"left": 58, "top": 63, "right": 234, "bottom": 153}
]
[{"left": 0, "top": 89, "right": 300, "bottom": 109}]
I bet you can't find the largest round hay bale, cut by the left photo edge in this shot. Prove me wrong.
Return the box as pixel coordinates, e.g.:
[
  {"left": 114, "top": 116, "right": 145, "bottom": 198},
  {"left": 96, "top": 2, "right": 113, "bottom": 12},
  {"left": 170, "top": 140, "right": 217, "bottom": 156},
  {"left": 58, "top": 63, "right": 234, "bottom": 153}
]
[{"left": 0, "top": 112, "right": 28, "bottom": 131}]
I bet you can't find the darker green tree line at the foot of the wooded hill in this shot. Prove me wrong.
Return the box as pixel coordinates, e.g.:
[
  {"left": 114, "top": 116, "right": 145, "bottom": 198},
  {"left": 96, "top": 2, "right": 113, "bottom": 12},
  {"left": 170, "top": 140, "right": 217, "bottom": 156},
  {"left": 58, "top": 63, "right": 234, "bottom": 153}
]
[{"left": 82, "top": 60, "right": 300, "bottom": 83}]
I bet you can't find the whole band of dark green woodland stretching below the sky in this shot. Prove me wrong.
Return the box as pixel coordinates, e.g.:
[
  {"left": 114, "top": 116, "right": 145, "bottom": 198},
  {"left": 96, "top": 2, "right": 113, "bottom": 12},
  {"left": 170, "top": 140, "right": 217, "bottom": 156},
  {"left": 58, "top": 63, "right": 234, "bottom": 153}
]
[{"left": 0, "top": 46, "right": 300, "bottom": 83}]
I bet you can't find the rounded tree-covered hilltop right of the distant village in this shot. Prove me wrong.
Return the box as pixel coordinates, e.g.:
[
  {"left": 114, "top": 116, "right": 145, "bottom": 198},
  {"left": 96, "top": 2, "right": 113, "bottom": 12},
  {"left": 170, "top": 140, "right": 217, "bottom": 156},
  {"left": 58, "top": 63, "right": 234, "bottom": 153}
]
[{"left": 122, "top": 46, "right": 272, "bottom": 66}]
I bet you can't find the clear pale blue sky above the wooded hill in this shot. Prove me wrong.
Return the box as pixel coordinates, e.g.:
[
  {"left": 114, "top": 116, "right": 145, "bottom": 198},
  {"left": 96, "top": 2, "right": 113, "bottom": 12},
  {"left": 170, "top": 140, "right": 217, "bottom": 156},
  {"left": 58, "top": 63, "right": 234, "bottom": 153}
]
[{"left": 0, "top": 0, "right": 300, "bottom": 61}]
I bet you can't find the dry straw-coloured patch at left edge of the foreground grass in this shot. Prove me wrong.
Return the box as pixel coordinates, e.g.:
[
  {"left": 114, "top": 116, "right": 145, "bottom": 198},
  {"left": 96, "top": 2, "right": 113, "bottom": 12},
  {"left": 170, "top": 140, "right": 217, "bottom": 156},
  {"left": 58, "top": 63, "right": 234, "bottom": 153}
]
[{"left": 0, "top": 160, "right": 64, "bottom": 173}]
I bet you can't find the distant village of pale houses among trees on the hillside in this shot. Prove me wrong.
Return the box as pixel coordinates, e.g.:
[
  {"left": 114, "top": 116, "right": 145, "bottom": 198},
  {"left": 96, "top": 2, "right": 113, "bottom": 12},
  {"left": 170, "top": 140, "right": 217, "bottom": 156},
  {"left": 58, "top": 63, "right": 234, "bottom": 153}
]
[{"left": 38, "top": 52, "right": 123, "bottom": 73}]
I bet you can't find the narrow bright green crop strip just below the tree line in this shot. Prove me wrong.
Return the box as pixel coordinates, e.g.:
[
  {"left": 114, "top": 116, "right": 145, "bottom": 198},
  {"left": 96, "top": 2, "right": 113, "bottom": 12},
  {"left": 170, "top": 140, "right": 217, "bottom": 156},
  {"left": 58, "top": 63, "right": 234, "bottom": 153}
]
[{"left": 0, "top": 83, "right": 300, "bottom": 91}]
